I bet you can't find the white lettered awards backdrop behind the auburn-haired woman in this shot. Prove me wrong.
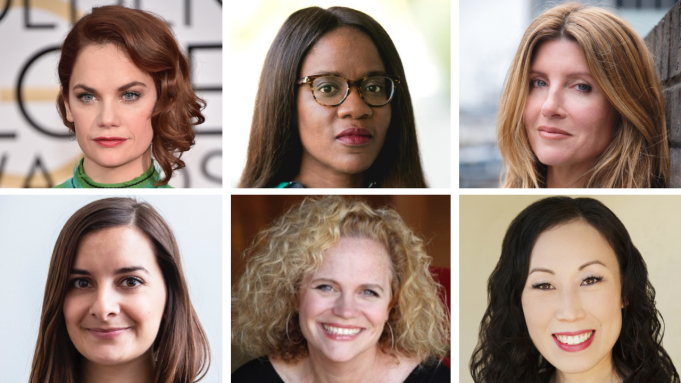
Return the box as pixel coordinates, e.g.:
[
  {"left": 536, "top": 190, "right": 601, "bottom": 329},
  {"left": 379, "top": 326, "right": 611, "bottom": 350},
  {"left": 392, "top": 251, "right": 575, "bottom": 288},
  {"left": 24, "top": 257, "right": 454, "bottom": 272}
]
[{"left": 0, "top": 0, "right": 222, "bottom": 188}]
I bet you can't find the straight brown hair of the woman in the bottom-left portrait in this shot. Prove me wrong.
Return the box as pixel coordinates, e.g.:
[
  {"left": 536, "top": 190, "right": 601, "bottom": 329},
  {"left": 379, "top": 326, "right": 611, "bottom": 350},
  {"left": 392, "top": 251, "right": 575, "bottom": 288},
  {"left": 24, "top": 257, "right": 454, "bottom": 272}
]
[{"left": 29, "top": 198, "right": 210, "bottom": 383}]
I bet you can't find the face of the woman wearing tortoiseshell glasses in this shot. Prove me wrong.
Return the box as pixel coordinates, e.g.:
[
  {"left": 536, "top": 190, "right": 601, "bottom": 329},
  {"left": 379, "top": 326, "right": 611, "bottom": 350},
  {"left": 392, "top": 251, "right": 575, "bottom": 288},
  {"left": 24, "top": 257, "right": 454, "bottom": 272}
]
[{"left": 297, "top": 27, "right": 390, "bottom": 180}]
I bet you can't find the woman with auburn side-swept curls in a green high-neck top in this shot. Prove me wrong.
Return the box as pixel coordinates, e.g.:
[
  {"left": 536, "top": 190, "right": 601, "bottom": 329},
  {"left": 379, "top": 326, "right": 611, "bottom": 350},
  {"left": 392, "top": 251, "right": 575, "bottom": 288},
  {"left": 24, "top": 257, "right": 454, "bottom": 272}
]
[{"left": 57, "top": 5, "right": 205, "bottom": 188}]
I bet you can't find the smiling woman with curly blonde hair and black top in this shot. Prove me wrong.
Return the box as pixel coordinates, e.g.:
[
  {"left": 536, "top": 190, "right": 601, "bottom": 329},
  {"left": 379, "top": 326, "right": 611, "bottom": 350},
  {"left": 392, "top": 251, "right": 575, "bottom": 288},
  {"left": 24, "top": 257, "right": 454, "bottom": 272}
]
[{"left": 232, "top": 196, "right": 450, "bottom": 383}]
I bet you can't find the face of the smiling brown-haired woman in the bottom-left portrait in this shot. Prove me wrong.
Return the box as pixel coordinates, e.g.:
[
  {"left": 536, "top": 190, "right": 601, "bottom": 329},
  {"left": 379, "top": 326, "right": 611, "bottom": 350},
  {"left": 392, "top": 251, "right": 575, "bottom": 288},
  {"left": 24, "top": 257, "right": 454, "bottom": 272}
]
[{"left": 64, "top": 226, "right": 166, "bottom": 365}]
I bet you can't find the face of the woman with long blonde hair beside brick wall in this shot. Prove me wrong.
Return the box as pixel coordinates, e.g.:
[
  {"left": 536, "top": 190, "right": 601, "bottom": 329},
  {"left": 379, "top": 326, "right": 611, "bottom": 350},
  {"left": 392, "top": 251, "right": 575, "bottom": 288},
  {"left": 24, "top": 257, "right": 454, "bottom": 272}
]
[{"left": 524, "top": 39, "right": 617, "bottom": 172}]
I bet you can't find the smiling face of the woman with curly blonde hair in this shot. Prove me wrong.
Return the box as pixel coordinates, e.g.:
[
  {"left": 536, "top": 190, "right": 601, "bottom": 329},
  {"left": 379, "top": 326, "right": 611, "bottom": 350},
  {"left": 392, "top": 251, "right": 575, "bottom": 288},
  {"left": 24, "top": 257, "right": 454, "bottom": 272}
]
[{"left": 298, "top": 237, "right": 392, "bottom": 362}]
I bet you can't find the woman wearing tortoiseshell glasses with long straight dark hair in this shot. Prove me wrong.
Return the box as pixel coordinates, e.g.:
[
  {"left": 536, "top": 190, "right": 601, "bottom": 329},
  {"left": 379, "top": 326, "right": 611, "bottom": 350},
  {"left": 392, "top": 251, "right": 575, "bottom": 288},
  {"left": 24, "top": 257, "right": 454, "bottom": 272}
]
[{"left": 239, "top": 7, "right": 426, "bottom": 188}]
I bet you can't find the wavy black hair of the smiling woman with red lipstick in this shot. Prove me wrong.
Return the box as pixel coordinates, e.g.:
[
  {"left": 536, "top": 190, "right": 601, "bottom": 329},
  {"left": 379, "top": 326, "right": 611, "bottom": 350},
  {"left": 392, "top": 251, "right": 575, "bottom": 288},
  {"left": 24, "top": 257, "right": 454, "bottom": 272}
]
[{"left": 470, "top": 197, "right": 680, "bottom": 383}]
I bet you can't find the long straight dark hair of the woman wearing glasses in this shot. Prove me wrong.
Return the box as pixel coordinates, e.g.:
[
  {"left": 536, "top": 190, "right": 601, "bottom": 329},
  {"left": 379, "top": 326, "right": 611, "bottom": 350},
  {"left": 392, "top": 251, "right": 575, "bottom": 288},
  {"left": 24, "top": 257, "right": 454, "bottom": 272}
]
[{"left": 239, "top": 7, "right": 426, "bottom": 188}]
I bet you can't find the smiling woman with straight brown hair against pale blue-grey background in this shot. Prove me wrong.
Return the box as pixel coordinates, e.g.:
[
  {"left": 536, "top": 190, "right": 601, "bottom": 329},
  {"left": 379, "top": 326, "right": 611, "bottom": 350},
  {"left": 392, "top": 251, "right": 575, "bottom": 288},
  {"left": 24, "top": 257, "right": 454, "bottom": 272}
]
[{"left": 29, "top": 198, "right": 210, "bottom": 383}]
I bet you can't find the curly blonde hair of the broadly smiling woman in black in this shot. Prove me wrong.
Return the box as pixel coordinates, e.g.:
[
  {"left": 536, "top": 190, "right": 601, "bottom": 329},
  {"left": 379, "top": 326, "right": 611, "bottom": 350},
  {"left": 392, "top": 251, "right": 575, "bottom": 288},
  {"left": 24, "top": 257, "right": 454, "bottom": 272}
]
[{"left": 232, "top": 196, "right": 449, "bottom": 363}]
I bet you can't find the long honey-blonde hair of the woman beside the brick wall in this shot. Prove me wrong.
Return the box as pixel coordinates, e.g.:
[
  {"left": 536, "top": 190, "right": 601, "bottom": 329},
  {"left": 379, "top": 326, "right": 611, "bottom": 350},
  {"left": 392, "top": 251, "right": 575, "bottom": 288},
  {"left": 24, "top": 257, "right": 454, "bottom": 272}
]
[{"left": 497, "top": 3, "right": 670, "bottom": 188}]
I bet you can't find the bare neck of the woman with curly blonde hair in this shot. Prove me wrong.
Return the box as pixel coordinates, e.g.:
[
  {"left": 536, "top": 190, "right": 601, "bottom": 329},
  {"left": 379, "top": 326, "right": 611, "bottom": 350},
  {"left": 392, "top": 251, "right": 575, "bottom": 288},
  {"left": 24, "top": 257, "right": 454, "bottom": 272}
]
[{"left": 304, "top": 348, "right": 383, "bottom": 383}]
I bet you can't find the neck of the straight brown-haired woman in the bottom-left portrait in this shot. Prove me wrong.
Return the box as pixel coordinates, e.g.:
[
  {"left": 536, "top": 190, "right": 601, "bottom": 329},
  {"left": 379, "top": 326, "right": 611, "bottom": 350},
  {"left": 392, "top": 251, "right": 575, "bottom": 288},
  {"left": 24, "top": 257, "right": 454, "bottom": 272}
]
[{"left": 83, "top": 350, "right": 154, "bottom": 383}]
